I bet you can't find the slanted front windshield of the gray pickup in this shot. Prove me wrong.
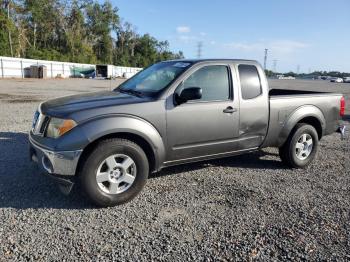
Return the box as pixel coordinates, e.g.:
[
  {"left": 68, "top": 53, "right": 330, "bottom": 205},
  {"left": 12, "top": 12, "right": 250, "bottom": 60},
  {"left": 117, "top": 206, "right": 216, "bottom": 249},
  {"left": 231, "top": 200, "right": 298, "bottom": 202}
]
[{"left": 116, "top": 61, "right": 191, "bottom": 96}]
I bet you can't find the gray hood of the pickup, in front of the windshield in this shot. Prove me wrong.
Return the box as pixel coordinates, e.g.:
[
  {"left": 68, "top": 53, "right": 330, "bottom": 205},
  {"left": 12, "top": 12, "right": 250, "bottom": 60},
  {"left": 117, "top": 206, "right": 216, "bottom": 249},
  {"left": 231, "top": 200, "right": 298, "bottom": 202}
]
[{"left": 41, "top": 91, "right": 150, "bottom": 117}]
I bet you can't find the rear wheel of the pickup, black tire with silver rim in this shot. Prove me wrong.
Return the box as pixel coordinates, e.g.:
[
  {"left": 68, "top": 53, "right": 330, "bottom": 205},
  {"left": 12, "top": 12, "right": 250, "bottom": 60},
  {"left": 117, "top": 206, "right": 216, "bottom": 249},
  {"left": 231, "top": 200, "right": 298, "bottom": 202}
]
[{"left": 279, "top": 123, "right": 318, "bottom": 168}]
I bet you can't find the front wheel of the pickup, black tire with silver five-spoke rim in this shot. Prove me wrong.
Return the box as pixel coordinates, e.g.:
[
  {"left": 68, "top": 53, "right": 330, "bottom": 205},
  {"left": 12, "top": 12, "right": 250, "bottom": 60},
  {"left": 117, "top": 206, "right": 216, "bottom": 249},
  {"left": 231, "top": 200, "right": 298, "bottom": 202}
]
[{"left": 79, "top": 138, "right": 149, "bottom": 207}]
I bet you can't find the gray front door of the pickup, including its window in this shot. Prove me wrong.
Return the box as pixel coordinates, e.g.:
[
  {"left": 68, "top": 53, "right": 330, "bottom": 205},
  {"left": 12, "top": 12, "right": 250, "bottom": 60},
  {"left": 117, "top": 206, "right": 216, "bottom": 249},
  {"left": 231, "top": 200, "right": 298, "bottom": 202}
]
[{"left": 167, "top": 63, "right": 239, "bottom": 162}]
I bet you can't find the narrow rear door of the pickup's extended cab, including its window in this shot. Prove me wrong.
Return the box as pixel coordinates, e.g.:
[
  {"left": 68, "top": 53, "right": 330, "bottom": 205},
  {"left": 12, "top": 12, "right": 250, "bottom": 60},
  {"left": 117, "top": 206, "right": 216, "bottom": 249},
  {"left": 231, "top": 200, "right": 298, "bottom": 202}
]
[{"left": 236, "top": 63, "right": 269, "bottom": 149}]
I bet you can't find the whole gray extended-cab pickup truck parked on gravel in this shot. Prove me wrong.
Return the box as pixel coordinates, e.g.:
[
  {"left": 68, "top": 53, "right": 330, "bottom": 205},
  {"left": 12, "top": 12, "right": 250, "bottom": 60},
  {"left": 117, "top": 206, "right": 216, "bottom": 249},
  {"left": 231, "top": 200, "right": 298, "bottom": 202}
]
[{"left": 29, "top": 59, "right": 345, "bottom": 206}]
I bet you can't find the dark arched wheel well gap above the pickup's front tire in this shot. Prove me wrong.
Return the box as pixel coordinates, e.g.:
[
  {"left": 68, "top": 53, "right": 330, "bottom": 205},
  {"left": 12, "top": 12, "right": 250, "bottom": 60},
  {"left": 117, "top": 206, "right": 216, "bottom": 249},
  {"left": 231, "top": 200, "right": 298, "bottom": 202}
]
[{"left": 77, "top": 133, "right": 156, "bottom": 176}]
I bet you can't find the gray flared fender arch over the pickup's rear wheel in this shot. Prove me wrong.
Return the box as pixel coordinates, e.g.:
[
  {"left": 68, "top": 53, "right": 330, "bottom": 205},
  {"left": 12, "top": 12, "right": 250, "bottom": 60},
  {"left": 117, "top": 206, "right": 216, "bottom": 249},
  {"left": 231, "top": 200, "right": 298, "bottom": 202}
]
[{"left": 278, "top": 105, "right": 326, "bottom": 146}]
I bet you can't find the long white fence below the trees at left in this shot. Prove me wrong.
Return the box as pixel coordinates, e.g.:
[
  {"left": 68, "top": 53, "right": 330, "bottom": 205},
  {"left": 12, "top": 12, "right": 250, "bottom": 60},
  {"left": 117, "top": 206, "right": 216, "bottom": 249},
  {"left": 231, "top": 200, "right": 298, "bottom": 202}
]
[{"left": 0, "top": 56, "right": 142, "bottom": 78}]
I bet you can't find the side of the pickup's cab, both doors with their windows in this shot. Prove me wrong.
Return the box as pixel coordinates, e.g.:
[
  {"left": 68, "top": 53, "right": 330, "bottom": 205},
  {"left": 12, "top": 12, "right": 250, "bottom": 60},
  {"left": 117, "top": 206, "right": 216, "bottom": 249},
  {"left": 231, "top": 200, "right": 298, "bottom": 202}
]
[{"left": 164, "top": 61, "right": 269, "bottom": 162}]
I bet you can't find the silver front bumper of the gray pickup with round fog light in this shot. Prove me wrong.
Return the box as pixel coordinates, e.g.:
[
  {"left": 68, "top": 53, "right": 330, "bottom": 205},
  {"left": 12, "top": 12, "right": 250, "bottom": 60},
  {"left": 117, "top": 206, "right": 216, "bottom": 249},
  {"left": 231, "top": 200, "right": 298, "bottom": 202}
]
[{"left": 29, "top": 135, "right": 83, "bottom": 178}]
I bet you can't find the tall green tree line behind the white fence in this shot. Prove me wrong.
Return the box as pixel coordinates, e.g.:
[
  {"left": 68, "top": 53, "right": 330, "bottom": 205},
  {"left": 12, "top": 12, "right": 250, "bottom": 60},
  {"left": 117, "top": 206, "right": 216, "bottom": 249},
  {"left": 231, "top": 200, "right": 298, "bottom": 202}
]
[{"left": 0, "top": 0, "right": 183, "bottom": 67}]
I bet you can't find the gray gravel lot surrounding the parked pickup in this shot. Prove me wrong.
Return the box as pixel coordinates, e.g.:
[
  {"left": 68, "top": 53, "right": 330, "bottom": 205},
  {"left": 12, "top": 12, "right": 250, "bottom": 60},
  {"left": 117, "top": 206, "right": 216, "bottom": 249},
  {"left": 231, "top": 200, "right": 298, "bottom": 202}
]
[{"left": 0, "top": 79, "right": 350, "bottom": 261}]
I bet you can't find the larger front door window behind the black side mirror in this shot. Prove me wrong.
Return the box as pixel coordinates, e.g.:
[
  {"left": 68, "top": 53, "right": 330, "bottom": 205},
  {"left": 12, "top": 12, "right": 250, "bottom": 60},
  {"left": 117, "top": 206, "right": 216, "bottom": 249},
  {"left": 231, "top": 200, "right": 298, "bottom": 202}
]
[{"left": 178, "top": 65, "right": 230, "bottom": 101}]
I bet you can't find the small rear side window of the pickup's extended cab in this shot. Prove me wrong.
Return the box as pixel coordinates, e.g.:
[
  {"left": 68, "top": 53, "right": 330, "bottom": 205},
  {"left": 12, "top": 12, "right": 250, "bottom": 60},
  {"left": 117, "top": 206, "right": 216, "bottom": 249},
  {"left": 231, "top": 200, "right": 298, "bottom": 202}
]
[{"left": 238, "top": 65, "right": 262, "bottom": 99}]
